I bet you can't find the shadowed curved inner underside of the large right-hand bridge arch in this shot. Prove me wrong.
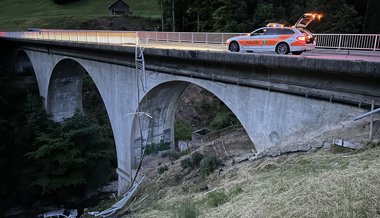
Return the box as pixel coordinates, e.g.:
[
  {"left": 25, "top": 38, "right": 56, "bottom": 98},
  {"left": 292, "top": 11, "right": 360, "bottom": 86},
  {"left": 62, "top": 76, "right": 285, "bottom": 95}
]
[{"left": 131, "top": 80, "right": 256, "bottom": 168}]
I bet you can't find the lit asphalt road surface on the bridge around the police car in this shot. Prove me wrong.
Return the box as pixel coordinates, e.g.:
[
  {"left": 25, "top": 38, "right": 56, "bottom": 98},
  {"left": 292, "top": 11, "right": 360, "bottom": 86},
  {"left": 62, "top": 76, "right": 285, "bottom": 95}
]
[{"left": 138, "top": 42, "right": 380, "bottom": 62}]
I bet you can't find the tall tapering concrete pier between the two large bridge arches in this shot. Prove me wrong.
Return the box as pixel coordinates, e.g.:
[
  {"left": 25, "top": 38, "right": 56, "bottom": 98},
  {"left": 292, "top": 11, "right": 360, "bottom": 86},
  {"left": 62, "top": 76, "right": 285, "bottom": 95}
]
[{"left": 78, "top": 59, "right": 138, "bottom": 194}]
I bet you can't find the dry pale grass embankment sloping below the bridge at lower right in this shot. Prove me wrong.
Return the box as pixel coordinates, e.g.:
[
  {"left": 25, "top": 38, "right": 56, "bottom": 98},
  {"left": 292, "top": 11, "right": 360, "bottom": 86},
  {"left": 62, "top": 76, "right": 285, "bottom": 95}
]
[{"left": 122, "top": 145, "right": 380, "bottom": 218}]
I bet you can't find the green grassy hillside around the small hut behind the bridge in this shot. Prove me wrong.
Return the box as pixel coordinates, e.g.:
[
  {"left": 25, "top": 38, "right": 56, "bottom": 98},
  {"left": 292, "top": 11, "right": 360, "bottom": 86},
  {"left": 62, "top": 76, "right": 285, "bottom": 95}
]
[{"left": 0, "top": 0, "right": 160, "bottom": 31}]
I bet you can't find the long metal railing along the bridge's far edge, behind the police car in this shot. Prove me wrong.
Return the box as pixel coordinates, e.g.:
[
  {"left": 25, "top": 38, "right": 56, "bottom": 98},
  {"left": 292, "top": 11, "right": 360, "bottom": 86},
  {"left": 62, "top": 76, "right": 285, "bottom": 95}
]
[{"left": 0, "top": 29, "right": 380, "bottom": 51}]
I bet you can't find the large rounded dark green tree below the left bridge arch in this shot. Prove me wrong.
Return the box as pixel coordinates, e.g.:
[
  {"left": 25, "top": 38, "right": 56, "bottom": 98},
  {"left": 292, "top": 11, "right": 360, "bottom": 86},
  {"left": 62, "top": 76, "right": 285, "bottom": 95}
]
[{"left": 26, "top": 114, "right": 115, "bottom": 197}]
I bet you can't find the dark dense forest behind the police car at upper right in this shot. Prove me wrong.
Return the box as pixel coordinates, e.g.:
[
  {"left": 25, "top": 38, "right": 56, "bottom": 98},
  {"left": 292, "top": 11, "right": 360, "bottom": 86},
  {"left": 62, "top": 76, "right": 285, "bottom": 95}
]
[{"left": 157, "top": 0, "right": 380, "bottom": 33}]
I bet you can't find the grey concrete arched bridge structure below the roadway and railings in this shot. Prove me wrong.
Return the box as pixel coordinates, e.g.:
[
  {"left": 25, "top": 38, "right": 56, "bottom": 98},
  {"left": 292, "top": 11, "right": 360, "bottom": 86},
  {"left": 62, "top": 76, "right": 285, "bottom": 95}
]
[{"left": 0, "top": 32, "right": 380, "bottom": 193}]
